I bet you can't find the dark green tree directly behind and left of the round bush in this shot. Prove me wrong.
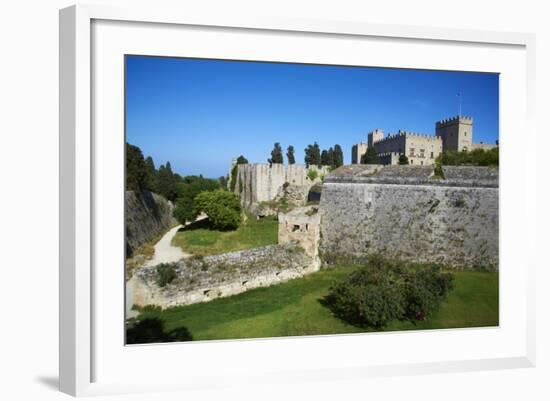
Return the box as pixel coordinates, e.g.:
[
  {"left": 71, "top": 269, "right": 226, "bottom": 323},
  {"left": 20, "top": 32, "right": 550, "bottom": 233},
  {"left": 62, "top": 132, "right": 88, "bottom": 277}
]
[{"left": 174, "top": 175, "right": 220, "bottom": 224}]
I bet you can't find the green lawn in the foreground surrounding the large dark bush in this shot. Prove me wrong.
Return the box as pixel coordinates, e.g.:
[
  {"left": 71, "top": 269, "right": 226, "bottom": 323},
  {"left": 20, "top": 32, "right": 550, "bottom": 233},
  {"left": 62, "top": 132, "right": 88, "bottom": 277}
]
[{"left": 130, "top": 267, "right": 498, "bottom": 340}]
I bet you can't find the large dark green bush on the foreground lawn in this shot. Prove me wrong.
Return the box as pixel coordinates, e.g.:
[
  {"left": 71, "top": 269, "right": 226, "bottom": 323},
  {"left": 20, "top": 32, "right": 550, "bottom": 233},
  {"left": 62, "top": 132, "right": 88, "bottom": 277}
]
[{"left": 324, "top": 258, "right": 454, "bottom": 329}]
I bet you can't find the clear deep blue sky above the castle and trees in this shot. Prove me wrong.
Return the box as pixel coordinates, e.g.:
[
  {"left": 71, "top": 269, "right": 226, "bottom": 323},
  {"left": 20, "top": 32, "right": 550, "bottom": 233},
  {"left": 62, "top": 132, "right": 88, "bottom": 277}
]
[{"left": 126, "top": 56, "right": 499, "bottom": 177}]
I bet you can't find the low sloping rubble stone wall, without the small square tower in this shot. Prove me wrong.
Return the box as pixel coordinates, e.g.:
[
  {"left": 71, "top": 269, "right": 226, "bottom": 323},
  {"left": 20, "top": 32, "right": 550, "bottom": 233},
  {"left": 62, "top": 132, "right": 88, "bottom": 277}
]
[{"left": 131, "top": 243, "right": 318, "bottom": 308}]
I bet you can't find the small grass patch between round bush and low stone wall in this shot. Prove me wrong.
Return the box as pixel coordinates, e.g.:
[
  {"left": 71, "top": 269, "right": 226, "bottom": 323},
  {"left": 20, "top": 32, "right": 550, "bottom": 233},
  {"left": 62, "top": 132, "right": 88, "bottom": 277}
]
[{"left": 172, "top": 216, "right": 278, "bottom": 256}]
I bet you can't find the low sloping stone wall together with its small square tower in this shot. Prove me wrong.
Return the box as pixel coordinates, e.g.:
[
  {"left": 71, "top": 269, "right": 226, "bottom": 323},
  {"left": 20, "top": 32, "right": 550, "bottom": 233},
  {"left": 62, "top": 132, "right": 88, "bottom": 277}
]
[{"left": 128, "top": 207, "right": 321, "bottom": 308}]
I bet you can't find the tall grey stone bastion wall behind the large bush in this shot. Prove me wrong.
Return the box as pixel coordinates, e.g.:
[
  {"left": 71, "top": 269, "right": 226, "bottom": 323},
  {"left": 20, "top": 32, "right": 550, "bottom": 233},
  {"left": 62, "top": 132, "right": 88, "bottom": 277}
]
[{"left": 320, "top": 165, "right": 499, "bottom": 270}]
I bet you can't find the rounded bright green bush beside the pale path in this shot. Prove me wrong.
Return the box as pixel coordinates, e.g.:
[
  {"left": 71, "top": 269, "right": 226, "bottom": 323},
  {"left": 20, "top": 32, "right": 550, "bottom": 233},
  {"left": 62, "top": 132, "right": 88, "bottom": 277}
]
[{"left": 194, "top": 189, "right": 242, "bottom": 230}]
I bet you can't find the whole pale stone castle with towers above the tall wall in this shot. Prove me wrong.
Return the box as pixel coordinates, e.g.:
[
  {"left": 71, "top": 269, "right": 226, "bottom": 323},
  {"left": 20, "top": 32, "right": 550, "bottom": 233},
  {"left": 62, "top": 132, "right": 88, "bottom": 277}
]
[{"left": 351, "top": 116, "right": 496, "bottom": 166}]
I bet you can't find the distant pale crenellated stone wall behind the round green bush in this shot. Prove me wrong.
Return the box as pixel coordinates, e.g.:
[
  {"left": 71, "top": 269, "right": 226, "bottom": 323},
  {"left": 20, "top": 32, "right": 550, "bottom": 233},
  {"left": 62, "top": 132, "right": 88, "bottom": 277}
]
[{"left": 234, "top": 163, "right": 328, "bottom": 208}]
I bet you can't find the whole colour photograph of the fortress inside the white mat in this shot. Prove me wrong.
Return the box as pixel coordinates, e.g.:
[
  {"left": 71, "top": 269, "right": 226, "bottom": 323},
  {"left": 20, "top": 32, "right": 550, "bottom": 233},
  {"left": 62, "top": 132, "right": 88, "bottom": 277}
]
[{"left": 124, "top": 54, "right": 499, "bottom": 345}]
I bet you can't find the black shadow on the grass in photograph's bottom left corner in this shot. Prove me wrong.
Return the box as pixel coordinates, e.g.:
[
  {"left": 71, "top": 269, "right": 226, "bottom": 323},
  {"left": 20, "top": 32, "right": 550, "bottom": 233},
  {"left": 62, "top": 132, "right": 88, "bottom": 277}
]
[{"left": 126, "top": 318, "right": 193, "bottom": 344}]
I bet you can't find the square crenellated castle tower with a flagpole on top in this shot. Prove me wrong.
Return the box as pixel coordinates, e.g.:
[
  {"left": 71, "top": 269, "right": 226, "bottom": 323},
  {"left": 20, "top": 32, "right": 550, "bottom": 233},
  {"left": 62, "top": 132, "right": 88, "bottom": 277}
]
[{"left": 435, "top": 116, "right": 474, "bottom": 152}]
